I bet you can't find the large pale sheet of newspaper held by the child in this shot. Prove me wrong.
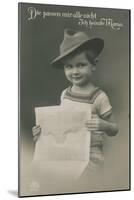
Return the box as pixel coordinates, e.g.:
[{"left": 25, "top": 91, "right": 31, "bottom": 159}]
[{"left": 33, "top": 105, "right": 91, "bottom": 179}]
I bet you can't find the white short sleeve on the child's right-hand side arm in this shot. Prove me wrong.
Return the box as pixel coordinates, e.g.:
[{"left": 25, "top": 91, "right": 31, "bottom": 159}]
[{"left": 95, "top": 92, "right": 112, "bottom": 118}]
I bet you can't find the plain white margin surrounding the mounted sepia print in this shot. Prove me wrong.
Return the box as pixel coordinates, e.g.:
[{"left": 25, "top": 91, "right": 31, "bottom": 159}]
[{"left": 0, "top": 0, "right": 134, "bottom": 200}]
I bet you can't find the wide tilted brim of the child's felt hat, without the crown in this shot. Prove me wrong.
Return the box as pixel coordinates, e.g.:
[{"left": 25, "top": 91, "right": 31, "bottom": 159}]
[{"left": 51, "top": 38, "right": 104, "bottom": 68}]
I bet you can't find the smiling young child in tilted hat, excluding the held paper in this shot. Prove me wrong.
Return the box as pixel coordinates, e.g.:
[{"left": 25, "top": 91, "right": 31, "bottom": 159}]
[{"left": 33, "top": 30, "right": 118, "bottom": 171}]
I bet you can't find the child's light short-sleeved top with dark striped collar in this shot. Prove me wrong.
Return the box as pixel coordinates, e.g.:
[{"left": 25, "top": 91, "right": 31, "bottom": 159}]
[{"left": 61, "top": 87, "right": 112, "bottom": 168}]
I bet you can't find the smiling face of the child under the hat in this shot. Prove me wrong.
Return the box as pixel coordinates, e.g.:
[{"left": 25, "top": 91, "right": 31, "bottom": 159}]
[{"left": 64, "top": 52, "right": 94, "bottom": 86}]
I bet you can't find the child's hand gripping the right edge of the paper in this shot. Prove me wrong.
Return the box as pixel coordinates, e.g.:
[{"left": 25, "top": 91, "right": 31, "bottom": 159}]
[{"left": 85, "top": 114, "right": 105, "bottom": 131}]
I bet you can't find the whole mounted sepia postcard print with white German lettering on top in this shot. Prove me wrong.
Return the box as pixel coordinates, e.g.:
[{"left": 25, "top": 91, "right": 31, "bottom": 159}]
[{"left": 18, "top": 3, "right": 130, "bottom": 197}]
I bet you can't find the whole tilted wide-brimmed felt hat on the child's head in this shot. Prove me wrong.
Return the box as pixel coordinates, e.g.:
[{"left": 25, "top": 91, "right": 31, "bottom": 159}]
[{"left": 51, "top": 29, "right": 104, "bottom": 68}]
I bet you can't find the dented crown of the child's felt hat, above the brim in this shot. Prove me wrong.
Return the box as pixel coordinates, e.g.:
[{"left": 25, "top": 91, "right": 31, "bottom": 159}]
[{"left": 60, "top": 29, "right": 89, "bottom": 53}]
